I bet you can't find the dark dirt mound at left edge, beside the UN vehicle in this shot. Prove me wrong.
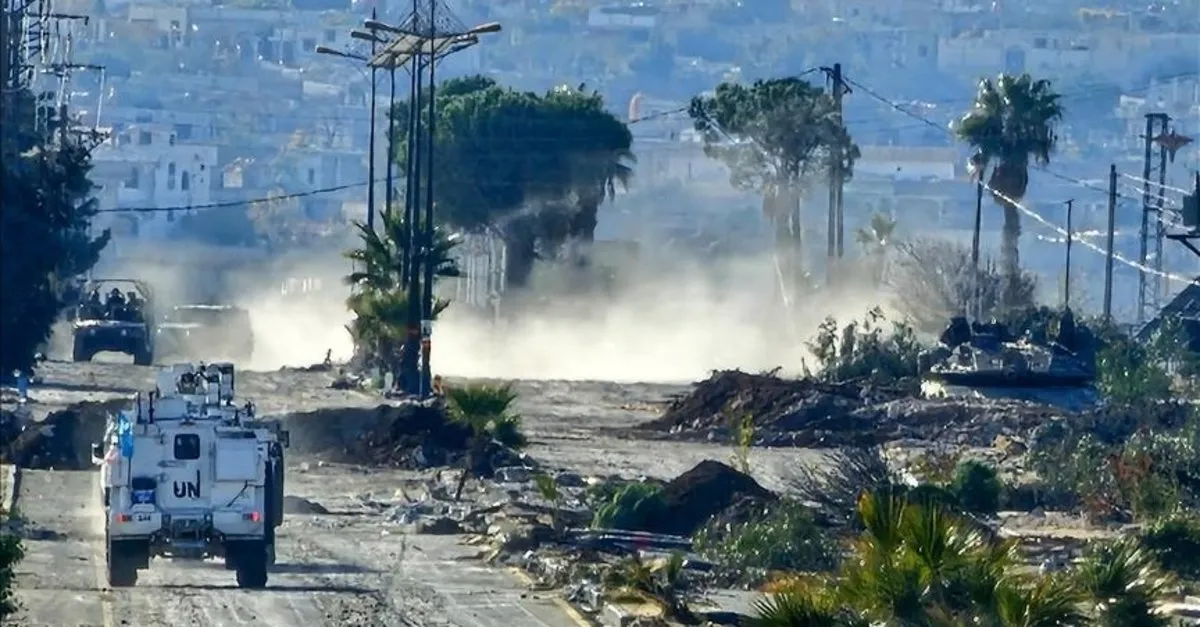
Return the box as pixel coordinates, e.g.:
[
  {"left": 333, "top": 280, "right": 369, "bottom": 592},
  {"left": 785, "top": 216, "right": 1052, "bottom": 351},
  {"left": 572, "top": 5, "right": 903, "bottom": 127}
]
[{"left": 0, "top": 399, "right": 131, "bottom": 470}]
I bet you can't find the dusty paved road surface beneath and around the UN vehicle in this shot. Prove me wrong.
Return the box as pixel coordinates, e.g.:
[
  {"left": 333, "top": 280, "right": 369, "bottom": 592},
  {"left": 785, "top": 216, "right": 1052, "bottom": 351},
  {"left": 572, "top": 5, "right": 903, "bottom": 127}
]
[{"left": 7, "top": 471, "right": 588, "bottom": 627}]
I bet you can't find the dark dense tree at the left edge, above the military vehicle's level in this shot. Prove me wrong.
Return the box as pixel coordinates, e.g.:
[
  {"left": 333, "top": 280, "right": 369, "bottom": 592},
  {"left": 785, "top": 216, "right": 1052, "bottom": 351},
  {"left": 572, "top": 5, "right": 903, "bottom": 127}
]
[{"left": 0, "top": 85, "right": 109, "bottom": 374}]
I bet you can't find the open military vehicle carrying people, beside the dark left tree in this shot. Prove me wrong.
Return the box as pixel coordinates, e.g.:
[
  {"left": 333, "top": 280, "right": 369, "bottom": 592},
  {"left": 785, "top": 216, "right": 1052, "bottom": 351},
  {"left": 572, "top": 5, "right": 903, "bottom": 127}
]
[{"left": 70, "top": 279, "right": 154, "bottom": 365}]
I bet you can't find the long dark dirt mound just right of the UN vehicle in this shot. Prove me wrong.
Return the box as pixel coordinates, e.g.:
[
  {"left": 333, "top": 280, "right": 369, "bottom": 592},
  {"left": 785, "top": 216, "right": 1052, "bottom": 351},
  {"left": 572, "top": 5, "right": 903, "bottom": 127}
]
[{"left": 283, "top": 402, "right": 469, "bottom": 468}]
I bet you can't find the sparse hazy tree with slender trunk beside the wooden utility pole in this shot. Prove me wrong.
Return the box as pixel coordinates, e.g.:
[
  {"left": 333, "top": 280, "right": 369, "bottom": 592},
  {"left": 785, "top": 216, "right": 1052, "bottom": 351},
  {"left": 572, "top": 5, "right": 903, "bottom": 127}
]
[{"left": 688, "top": 78, "right": 858, "bottom": 291}]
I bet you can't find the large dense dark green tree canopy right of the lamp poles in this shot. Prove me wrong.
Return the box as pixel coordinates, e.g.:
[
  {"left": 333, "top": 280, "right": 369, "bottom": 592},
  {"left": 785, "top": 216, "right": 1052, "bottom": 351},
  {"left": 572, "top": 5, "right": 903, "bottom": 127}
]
[{"left": 394, "top": 76, "right": 634, "bottom": 285}]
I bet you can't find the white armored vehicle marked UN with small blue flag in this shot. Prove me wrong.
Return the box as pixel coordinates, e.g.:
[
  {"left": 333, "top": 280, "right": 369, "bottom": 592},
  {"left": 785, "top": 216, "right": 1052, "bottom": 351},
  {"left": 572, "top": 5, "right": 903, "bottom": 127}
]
[{"left": 92, "top": 363, "right": 288, "bottom": 589}]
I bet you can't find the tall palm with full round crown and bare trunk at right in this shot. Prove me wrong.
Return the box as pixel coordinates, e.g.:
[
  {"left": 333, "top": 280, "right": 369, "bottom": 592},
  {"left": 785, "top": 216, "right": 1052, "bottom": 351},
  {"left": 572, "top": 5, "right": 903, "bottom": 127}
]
[{"left": 955, "top": 74, "right": 1063, "bottom": 307}]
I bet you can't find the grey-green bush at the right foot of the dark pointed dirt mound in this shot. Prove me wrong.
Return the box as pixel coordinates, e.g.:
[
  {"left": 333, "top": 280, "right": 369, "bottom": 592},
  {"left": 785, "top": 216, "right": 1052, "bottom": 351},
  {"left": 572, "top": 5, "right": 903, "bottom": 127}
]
[{"left": 695, "top": 501, "right": 838, "bottom": 580}]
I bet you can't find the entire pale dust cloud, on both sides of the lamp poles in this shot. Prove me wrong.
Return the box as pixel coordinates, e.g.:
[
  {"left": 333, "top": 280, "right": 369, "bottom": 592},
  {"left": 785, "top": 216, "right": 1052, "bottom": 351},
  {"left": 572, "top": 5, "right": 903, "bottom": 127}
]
[{"left": 79, "top": 237, "right": 897, "bottom": 382}]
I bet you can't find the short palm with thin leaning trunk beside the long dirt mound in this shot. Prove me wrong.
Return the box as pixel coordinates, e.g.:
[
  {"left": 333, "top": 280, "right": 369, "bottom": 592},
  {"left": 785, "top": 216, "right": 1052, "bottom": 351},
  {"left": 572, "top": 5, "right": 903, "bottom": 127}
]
[{"left": 446, "top": 383, "right": 524, "bottom": 501}]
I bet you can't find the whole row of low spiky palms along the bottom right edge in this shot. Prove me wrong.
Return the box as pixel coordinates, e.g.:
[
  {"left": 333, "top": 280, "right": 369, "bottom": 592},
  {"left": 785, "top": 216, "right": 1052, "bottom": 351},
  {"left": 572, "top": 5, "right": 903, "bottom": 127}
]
[{"left": 750, "top": 494, "right": 1171, "bottom": 627}]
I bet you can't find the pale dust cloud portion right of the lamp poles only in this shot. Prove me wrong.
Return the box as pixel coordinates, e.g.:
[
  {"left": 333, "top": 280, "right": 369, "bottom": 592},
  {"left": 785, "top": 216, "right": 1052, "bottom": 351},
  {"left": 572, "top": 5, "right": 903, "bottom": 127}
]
[{"left": 433, "top": 249, "right": 892, "bottom": 382}]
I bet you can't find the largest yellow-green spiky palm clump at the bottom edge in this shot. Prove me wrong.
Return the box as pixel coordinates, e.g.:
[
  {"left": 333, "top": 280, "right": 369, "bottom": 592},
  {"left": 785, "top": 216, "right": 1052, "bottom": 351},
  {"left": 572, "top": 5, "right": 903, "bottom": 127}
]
[{"left": 752, "top": 491, "right": 1088, "bottom": 627}]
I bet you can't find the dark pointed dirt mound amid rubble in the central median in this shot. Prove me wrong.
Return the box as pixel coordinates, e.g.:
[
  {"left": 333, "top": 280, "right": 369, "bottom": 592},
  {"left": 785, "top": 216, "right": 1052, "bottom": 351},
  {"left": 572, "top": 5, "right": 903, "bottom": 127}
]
[{"left": 650, "top": 460, "right": 775, "bottom": 536}]
